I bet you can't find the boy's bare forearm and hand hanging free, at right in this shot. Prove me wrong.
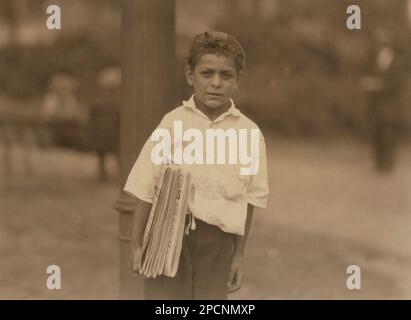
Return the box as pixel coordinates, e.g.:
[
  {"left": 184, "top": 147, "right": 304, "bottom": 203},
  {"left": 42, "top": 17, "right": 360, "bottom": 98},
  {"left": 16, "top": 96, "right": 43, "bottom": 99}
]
[{"left": 227, "top": 204, "right": 254, "bottom": 292}]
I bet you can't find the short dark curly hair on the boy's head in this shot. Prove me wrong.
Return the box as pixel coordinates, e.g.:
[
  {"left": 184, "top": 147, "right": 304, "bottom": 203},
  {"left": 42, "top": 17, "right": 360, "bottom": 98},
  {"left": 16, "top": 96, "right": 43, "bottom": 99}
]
[{"left": 188, "top": 31, "right": 245, "bottom": 73}]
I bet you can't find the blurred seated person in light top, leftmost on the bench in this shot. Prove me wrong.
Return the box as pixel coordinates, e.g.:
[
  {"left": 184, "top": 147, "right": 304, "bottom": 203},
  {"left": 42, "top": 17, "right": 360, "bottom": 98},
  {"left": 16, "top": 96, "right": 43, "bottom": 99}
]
[{"left": 41, "top": 73, "right": 87, "bottom": 148}]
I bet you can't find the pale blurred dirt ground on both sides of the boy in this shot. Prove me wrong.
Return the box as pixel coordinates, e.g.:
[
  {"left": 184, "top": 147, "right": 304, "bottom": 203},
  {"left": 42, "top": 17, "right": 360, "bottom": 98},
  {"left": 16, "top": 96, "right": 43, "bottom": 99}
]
[{"left": 0, "top": 138, "right": 411, "bottom": 299}]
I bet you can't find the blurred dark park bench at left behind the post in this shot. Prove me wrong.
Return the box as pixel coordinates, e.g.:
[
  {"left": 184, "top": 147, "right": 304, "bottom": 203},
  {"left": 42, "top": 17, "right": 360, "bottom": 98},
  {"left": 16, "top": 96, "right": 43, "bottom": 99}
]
[{"left": 0, "top": 106, "right": 119, "bottom": 181}]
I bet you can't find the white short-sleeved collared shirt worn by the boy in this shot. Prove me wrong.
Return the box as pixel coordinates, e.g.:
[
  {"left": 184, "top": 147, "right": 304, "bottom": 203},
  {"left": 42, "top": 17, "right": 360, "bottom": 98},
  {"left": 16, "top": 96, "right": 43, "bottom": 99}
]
[{"left": 124, "top": 96, "right": 269, "bottom": 235}]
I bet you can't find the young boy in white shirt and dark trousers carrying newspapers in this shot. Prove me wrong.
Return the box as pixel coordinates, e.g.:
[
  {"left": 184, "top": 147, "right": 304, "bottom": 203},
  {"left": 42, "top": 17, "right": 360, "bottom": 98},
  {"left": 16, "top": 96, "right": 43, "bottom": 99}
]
[{"left": 124, "top": 32, "right": 268, "bottom": 299}]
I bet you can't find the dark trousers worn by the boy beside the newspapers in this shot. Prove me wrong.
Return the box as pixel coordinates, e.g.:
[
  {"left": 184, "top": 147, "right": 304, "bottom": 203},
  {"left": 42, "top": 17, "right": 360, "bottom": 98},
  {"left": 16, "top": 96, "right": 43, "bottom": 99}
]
[{"left": 143, "top": 219, "right": 234, "bottom": 300}]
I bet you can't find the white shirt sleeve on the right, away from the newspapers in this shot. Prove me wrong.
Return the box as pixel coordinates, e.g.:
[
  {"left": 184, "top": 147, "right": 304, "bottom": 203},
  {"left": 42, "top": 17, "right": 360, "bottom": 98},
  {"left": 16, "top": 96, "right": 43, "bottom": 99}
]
[{"left": 247, "top": 131, "right": 269, "bottom": 208}]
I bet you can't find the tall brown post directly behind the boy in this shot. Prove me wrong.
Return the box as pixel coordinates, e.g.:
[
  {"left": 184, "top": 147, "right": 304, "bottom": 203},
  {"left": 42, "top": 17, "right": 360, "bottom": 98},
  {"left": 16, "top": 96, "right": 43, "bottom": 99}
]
[{"left": 115, "top": 0, "right": 175, "bottom": 299}]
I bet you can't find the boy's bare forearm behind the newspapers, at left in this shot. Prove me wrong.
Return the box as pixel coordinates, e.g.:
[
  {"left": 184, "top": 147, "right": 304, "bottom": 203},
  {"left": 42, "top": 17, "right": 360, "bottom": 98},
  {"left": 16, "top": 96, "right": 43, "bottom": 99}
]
[{"left": 130, "top": 199, "right": 152, "bottom": 271}]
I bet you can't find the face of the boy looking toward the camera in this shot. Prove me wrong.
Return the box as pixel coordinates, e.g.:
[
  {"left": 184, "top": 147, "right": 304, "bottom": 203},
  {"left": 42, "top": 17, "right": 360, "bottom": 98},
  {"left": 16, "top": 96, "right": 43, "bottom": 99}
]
[{"left": 186, "top": 53, "right": 238, "bottom": 109}]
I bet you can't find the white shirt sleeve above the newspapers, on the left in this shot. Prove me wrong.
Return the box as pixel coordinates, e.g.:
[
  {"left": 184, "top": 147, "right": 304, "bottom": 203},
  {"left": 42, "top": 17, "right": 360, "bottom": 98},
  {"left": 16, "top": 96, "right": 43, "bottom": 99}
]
[{"left": 123, "top": 117, "right": 171, "bottom": 203}]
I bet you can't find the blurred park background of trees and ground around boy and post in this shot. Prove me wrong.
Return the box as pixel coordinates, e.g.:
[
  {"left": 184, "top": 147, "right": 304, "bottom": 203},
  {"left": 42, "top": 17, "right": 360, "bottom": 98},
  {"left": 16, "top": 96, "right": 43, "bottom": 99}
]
[{"left": 0, "top": 0, "right": 411, "bottom": 299}]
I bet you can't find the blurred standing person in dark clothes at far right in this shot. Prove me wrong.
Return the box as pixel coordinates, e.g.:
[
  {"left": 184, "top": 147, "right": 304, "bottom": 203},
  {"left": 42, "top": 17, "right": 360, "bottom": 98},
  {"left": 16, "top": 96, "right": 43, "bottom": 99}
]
[{"left": 362, "top": 29, "right": 403, "bottom": 172}]
